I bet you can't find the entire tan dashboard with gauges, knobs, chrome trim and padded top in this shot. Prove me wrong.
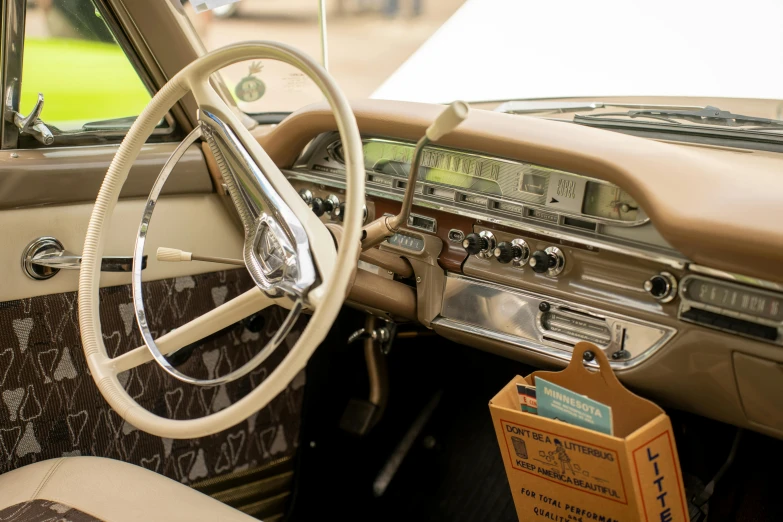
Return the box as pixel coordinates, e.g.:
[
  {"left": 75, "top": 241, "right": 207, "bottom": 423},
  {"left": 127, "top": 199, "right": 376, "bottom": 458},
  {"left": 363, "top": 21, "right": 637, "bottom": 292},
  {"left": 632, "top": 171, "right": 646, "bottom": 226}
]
[{"left": 260, "top": 97, "right": 783, "bottom": 438}]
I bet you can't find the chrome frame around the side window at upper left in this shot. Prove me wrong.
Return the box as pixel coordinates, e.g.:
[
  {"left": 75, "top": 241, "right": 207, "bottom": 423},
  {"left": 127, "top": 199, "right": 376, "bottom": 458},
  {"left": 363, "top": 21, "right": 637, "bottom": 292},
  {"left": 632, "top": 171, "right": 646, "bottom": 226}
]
[{"left": 0, "top": 0, "right": 182, "bottom": 150}]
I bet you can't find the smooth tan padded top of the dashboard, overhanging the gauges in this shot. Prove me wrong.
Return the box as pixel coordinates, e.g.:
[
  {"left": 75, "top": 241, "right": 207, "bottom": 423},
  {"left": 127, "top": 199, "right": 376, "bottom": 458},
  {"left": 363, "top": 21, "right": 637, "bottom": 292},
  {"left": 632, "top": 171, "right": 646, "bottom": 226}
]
[{"left": 258, "top": 100, "right": 783, "bottom": 281}]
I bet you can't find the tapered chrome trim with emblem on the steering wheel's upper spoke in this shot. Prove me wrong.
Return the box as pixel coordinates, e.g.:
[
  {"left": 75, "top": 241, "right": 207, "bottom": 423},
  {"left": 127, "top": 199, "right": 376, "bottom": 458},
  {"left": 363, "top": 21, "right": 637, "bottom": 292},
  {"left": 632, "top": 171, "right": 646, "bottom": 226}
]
[{"left": 199, "top": 109, "right": 316, "bottom": 299}]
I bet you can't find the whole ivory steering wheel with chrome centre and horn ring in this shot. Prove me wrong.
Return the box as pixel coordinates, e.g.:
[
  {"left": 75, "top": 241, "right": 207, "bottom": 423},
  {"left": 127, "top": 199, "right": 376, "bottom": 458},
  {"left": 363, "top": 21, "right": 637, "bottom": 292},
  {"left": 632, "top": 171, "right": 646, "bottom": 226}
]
[{"left": 79, "top": 42, "right": 364, "bottom": 439}]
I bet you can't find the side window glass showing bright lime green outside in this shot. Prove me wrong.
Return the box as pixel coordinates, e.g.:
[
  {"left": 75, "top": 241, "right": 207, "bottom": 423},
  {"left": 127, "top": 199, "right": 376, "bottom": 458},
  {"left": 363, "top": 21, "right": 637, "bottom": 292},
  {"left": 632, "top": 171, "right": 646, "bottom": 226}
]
[{"left": 20, "top": 0, "right": 151, "bottom": 132}]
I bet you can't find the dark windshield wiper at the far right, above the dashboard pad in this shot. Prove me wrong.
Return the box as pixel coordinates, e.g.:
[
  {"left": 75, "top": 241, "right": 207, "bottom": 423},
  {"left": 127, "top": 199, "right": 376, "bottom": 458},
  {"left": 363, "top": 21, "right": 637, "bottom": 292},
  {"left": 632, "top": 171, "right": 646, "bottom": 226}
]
[{"left": 574, "top": 105, "right": 783, "bottom": 128}]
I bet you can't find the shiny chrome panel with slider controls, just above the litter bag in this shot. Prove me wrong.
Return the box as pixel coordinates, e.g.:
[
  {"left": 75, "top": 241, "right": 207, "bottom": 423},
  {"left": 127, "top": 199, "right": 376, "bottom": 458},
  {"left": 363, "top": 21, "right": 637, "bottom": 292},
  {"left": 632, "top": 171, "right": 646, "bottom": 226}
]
[{"left": 432, "top": 274, "right": 677, "bottom": 371}]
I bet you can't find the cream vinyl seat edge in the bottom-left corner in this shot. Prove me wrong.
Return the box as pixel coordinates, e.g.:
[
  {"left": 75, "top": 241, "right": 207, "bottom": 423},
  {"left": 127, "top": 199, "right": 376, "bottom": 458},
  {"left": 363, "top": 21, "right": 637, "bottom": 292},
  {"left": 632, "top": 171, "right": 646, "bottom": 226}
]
[{"left": 0, "top": 457, "right": 257, "bottom": 522}]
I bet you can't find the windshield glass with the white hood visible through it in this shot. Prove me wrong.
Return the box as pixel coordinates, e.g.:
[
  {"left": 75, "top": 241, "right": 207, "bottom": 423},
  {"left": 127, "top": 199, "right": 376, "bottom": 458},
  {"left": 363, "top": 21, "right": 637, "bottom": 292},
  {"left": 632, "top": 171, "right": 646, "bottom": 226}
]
[{"left": 182, "top": 0, "right": 783, "bottom": 128}]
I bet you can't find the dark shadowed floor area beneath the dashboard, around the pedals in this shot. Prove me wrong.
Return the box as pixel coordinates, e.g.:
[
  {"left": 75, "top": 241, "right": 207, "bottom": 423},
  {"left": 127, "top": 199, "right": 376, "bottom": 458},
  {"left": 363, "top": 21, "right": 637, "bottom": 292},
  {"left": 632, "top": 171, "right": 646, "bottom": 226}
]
[{"left": 289, "top": 314, "right": 783, "bottom": 522}]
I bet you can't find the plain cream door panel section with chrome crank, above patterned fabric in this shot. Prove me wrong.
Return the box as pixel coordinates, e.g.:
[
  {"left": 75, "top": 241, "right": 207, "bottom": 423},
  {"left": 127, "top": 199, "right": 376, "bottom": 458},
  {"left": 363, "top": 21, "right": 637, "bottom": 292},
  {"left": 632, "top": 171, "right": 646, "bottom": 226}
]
[{"left": 0, "top": 194, "right": 244, "bottom": 302}]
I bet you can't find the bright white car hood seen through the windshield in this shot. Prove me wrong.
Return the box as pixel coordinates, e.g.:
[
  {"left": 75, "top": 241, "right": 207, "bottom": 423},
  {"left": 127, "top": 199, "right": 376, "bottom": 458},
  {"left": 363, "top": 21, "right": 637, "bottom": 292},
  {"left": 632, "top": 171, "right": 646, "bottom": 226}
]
[{"left": 372, "top": 0, "right": 783, "bottom": 102}]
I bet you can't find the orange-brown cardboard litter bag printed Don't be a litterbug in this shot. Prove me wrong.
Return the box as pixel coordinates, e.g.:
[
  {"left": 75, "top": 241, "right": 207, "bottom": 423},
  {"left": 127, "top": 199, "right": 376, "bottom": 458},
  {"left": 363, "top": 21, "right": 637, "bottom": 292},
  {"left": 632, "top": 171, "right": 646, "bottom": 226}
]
[{"left": 489, "top": 342, "right": 688, "bottom": 522}]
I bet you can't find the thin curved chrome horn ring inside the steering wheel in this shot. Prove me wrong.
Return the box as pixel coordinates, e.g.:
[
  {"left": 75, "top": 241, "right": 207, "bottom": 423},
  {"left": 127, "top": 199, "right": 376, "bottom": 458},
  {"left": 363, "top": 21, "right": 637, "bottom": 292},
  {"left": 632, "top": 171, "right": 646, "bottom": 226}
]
[{"left": 131, "top": 126, "right": 303, "bottom": 386}]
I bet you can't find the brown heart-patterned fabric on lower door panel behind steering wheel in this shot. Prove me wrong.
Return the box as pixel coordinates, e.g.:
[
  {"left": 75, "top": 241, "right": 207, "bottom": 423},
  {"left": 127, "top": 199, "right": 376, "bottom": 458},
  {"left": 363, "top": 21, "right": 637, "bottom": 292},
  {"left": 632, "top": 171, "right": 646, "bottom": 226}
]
[{"left": 0, "top": 269, "right": 304, "bottom": 483}]
